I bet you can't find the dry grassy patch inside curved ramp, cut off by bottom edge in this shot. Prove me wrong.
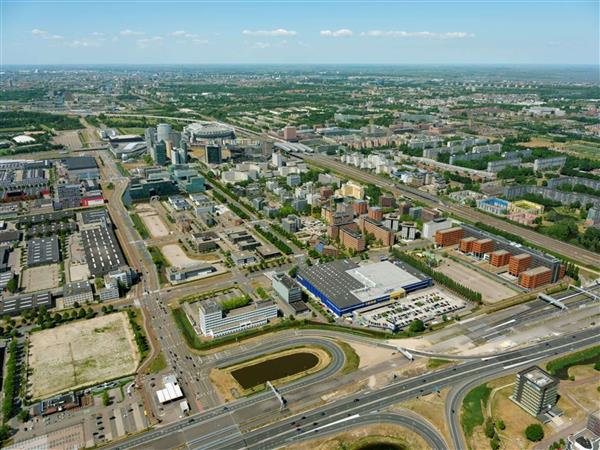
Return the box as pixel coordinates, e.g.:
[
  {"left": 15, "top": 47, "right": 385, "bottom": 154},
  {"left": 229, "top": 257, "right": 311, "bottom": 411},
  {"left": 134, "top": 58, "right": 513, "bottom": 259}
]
[{"left": 285, "top": 424, "right": 429, "bottom": 450}]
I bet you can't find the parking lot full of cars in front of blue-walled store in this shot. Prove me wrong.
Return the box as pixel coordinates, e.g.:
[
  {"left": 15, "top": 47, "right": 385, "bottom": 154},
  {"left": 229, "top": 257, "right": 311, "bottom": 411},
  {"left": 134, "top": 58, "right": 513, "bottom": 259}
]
[{"left": 355, "top": 289, "right": 467, "bottom": 330}]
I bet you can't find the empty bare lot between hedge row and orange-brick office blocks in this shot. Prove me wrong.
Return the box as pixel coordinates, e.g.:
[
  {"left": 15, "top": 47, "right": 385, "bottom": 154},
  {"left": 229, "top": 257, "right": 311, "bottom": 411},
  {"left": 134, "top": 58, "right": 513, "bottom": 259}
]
[{"left": 436, "top": 258, "right": 518, "bottom": 303}]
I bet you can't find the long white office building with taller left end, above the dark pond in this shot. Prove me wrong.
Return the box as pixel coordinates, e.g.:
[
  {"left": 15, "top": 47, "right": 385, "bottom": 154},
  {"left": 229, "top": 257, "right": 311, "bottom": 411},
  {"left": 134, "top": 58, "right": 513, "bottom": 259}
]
[{"left": 198, "top": 300, "right": 277, "bottom": 338}]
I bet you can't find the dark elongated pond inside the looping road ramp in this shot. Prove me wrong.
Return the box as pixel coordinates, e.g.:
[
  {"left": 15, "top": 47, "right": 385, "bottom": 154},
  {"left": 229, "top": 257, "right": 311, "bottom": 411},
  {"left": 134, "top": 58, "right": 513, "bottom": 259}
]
[{"left": 231, "top": 352, "right": 319, "bottom": 389}]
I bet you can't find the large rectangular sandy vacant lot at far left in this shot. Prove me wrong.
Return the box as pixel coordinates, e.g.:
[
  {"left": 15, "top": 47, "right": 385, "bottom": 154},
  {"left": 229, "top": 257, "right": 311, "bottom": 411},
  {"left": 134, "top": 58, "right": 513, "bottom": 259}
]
[{"left": 29, "top": 312, "right": 140, "bottom": 399}]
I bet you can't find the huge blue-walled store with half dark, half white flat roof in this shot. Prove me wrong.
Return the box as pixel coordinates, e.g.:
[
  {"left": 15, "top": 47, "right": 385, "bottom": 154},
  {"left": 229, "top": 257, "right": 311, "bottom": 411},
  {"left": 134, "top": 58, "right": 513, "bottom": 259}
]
[{"left": 297, "top": 260, "right": 431, "bottom": 316}]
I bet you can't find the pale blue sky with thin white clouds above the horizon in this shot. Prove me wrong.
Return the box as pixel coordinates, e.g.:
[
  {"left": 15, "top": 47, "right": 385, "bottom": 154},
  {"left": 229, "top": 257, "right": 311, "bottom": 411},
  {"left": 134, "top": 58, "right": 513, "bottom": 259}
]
[{"left": 0, "top": 0, "right": 600, "bottom": 65}]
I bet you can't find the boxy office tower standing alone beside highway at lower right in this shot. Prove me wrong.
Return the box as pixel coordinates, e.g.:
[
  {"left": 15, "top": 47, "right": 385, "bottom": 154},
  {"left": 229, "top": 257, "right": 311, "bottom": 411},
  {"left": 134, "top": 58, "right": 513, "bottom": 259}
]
[{"left": 511, "top": 366, "right": 558, "bottom": 417}]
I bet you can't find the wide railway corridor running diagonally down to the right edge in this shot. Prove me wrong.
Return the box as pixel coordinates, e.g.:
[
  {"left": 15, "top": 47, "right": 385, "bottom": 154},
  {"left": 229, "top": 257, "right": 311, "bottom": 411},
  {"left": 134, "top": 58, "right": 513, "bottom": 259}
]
[{"left": 294, "top": 153, "right": 600, "bottom": 267}]
